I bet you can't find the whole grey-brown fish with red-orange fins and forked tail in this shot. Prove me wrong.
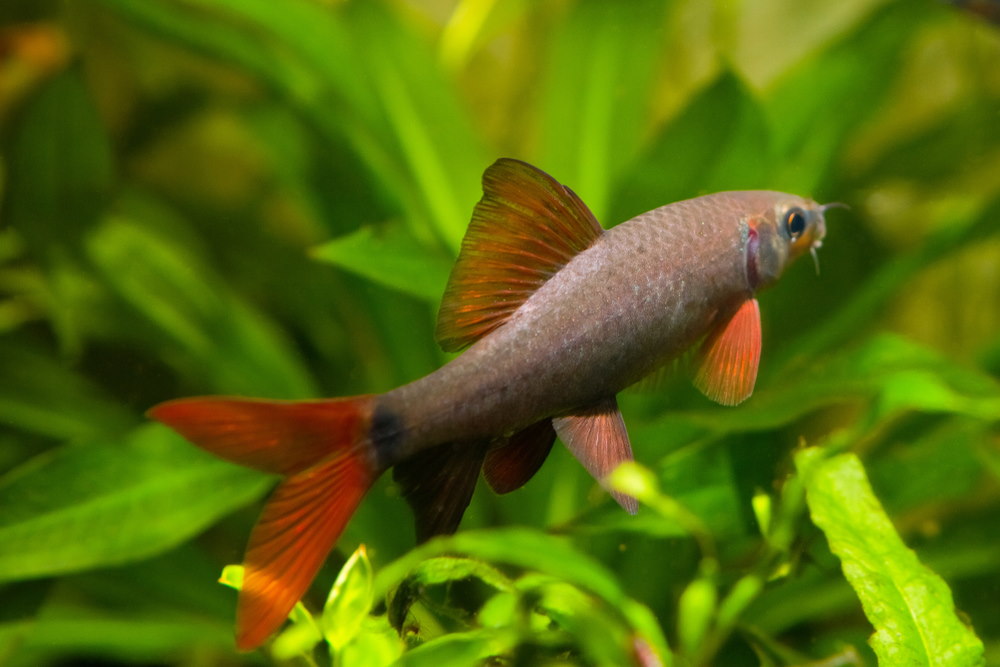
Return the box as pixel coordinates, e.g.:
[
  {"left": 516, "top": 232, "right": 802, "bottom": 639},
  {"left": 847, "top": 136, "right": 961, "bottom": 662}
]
[{"left": 148, "top": 158, "right": 826, "bottom": 650}]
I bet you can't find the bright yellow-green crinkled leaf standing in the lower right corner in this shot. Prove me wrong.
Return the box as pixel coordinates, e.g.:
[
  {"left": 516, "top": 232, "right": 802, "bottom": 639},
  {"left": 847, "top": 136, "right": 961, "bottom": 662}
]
[{"left": 795, "top": 448, "right": 984, "bottom": 665}]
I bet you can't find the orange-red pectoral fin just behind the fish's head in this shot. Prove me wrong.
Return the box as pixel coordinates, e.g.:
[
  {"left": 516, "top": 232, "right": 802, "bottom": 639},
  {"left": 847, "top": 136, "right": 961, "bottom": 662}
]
[{"left": 694, "top": 299, "right": 760, "bottom": 405}]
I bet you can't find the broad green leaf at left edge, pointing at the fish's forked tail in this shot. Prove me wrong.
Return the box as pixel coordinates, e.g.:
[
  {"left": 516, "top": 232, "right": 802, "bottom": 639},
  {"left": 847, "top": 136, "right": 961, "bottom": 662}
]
[{"left": 0, "top": 425, "right": 268, "bottom": 581}]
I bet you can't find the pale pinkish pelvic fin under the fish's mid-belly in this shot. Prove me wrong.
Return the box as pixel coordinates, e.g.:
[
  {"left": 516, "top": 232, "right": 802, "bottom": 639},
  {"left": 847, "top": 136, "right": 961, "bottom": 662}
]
[{"left": 552, "top": 397, "right": 638, "bottom": 514}]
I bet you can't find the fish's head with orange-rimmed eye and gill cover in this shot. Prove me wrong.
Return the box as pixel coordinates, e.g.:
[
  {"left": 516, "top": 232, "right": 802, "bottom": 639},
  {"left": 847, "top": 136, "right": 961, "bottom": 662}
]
[{"left": 746, "top": 192, "right": 829, "bottom": 291}]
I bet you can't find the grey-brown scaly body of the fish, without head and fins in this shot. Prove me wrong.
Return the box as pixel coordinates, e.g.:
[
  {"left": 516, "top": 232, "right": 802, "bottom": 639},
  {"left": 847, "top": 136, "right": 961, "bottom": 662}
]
[{"left": 379, "top": 192, "right": 805, "bottom": 457}]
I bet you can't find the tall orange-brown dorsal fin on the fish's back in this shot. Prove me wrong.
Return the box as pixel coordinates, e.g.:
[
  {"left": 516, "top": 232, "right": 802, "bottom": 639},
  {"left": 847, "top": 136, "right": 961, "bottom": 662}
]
[{"left": 435, "top": 158, "right": 603, "bottom": 352}]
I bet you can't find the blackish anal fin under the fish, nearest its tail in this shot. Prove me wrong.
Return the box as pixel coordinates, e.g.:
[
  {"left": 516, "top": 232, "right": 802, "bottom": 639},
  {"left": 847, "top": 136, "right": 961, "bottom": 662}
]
[{"left": 392, "top": 442, "right": 487, "bottom": 542}]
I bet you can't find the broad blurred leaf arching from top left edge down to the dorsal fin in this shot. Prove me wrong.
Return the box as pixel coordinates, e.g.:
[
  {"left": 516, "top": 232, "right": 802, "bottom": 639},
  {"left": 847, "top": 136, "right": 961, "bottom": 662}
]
[{"left": 101, "top": 0, "right": 488, "bottom": 250}]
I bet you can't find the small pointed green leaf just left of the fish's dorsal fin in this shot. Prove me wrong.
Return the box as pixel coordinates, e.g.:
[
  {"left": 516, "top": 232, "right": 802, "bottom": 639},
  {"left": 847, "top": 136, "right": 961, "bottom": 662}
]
[{"left": 311, "top": 226, "right": 451, "bottom": 305}]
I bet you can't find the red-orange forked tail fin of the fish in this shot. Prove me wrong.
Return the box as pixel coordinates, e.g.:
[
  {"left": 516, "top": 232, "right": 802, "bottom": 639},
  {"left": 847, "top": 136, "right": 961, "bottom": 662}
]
[{"left": 148, "top": 396, "right": 381, "bottom": 651}]
